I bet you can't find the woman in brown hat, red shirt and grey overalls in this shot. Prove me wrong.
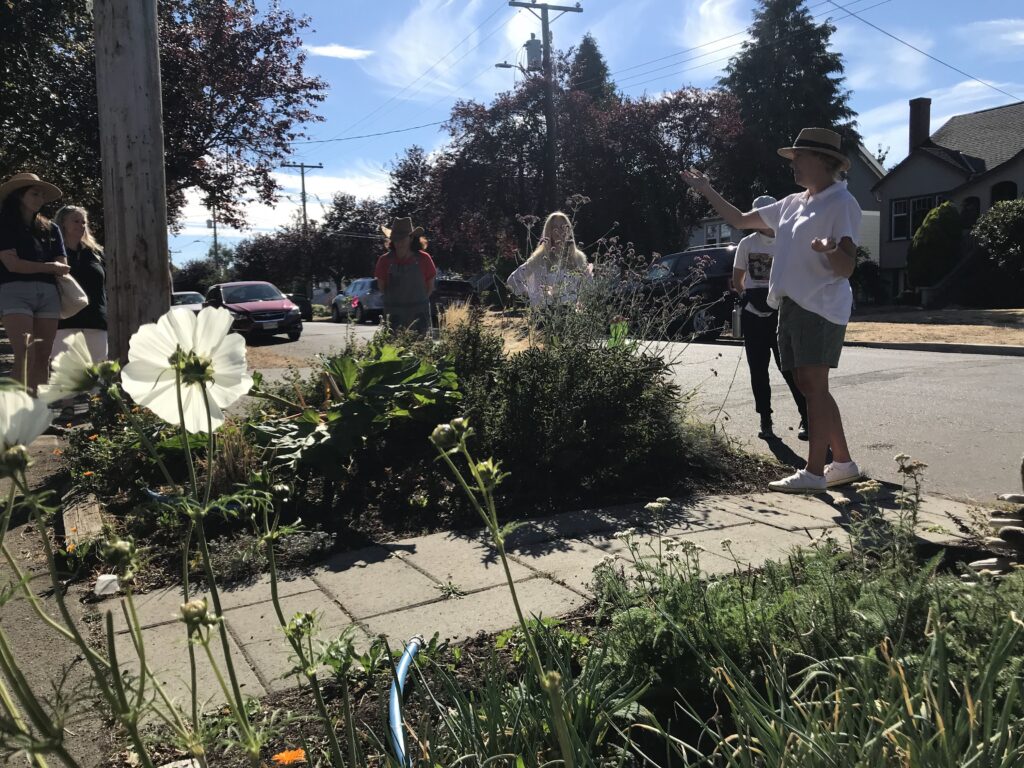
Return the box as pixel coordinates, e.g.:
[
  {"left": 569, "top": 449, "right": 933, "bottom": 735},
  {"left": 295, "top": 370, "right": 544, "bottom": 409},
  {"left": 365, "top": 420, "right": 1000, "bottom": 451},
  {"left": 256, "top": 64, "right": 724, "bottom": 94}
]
[{"left": 374, "top": 217, "right": 437, "bottom": 334}]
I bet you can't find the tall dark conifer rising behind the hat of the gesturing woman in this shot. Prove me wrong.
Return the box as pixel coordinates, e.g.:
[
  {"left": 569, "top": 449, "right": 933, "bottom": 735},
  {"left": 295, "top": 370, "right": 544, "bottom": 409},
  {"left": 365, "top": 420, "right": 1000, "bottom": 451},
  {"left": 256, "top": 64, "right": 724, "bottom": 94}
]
[{"left": 720, "top": 0, "right": 860, "bottom": 205}]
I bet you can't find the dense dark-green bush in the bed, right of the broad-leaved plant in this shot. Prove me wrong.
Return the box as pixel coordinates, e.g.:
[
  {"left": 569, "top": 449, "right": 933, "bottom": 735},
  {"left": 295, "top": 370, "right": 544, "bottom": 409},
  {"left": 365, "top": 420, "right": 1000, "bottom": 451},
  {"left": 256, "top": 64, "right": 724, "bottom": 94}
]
[{"left": 463, "top": 342, "right": 686, "bottom": 501}]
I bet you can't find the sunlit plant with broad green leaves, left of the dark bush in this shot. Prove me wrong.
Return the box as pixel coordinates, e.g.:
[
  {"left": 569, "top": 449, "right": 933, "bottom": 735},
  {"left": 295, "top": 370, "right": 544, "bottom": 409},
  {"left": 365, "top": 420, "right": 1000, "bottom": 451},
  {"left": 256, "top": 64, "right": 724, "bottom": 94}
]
[{"left": 252, "top": 344, "right": 460, "bottom": 475}]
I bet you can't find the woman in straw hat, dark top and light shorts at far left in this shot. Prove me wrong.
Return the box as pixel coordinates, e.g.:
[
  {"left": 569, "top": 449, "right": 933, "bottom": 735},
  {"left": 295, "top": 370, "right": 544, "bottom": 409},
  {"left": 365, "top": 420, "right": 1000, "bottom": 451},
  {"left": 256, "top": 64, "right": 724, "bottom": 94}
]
[{"left": 0, "top": 173, "right": 69, "bottom": 393}]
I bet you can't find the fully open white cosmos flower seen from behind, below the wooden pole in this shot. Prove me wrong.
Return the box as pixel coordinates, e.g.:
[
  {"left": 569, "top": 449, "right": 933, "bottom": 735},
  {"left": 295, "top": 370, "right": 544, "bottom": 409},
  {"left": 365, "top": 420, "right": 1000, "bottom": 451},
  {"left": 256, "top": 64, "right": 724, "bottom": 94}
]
[{"left": 121, "top": 307, "right": 253, "bottom": 432}]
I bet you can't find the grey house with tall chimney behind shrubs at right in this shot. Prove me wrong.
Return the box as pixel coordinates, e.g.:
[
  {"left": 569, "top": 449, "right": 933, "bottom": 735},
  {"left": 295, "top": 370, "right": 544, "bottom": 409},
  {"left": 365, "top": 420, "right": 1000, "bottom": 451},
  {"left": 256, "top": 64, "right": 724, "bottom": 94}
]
[{"left": 874, "top": 98, "right": 1024, "bottom": 295}]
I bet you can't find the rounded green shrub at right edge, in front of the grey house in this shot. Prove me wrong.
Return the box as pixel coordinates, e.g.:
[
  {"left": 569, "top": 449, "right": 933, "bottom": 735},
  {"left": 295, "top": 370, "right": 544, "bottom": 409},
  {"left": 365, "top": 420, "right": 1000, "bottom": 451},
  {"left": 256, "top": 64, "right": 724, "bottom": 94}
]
[{"left": 971, "top": 200, "right": 1024, "bottom": 306}]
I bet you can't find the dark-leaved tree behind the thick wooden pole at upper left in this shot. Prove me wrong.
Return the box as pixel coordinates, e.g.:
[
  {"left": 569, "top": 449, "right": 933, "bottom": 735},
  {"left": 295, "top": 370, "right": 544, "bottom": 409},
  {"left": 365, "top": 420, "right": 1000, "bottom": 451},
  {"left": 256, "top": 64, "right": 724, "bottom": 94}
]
[{"left": 0, "top": 0, "right": 326, "bottom": 231}]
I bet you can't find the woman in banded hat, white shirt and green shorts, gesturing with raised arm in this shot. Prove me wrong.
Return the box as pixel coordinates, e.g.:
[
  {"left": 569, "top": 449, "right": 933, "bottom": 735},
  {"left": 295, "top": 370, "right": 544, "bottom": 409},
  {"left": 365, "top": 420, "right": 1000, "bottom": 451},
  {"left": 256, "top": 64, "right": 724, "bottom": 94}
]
[{"left": 683, "top": 128, "right": 862, "bottom": 494}]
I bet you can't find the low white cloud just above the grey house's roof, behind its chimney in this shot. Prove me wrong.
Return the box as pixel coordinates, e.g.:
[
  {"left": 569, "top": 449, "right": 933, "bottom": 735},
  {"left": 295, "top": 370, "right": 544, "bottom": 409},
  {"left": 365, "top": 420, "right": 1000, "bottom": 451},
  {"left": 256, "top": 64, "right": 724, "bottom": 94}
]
[{"left": 857, "top": 80, "right": 1024, "bottom": 167}]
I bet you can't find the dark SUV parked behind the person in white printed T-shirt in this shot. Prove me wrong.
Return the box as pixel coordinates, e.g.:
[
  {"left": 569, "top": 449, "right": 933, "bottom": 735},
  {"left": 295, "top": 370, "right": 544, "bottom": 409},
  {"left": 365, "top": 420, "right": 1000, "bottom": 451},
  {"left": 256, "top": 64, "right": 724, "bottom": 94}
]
[{"left": 642, "top": 245, "right": 736, "bottom": 341}]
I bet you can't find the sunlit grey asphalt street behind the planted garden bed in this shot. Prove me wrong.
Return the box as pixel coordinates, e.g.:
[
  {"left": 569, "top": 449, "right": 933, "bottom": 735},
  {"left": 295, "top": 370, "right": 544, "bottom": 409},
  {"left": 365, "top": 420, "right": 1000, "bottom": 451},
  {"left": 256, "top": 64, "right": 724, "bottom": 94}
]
[{"left": 243, "top": 323, "right": 1024, "bottom": 501}]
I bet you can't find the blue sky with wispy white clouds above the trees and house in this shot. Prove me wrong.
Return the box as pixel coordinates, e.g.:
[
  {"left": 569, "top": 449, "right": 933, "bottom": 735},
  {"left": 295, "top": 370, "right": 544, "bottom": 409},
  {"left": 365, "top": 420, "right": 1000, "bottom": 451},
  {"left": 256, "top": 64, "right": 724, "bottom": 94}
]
[{"left": 171, "top": 0, "right": 1024, "bottom": 264}]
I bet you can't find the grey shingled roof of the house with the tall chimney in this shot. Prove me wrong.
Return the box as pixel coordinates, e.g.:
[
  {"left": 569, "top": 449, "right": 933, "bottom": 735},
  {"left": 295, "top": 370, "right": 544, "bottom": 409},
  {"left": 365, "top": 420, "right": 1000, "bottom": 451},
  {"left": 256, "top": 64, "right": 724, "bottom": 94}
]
[{"left": 872, "top": 101, "right": 1024, "bottom": 188}]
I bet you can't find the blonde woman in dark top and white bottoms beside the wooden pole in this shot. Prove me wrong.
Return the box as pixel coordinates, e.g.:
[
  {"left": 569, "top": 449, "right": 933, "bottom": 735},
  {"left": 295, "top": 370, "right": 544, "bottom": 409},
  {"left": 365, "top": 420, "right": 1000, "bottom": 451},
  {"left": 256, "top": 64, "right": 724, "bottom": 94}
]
[{"left": 50, "top": 206, "right": 106, "bottom": 360}]
